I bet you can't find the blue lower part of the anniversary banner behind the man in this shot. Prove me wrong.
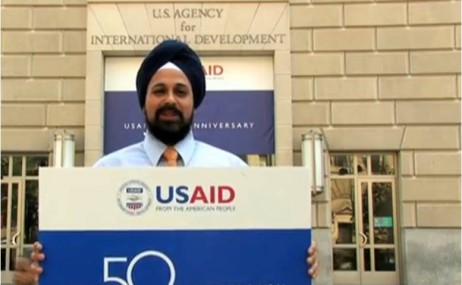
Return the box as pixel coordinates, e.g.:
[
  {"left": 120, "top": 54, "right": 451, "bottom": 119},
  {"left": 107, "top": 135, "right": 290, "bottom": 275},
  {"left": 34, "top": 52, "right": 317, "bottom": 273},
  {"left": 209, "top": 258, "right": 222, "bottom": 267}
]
[{"left": 104, "top": 91, "right": 275, "bottom": 155}]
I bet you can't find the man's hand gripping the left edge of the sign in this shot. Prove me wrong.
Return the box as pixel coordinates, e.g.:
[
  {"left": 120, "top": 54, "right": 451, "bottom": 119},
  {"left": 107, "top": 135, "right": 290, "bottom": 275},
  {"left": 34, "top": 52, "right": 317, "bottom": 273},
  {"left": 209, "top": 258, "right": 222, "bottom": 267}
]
[{"left": 14, "top": 242, "right": 45, "bottom": 285}]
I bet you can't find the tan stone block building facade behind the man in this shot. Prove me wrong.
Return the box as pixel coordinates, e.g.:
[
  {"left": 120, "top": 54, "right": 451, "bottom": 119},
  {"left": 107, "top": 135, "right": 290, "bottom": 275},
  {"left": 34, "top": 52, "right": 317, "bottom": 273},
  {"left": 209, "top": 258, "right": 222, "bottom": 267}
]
[{"left": 1, "top": 0, "right": 461, "bottom": 285}]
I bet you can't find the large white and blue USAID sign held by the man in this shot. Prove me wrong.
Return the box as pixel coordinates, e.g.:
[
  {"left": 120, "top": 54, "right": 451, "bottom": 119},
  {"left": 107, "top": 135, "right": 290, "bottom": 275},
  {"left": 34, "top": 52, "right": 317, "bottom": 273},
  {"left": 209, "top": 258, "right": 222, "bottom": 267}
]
[{"left": 39, "top": 167, "right": 311, "bottom": 285}]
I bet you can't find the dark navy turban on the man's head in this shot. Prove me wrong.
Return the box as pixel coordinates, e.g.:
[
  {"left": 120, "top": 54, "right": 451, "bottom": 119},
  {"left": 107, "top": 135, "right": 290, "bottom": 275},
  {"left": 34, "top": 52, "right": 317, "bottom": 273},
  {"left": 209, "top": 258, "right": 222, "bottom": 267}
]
[{"left": 136, "top": 40, "right": 205, "bottom": 109}]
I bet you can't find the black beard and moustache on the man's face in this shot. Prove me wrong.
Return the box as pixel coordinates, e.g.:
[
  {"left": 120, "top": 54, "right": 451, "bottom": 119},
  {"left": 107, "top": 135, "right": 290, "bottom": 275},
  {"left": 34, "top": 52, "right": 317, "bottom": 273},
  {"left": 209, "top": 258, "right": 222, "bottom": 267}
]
[{"left": 144, "top": 104, "right": 193, "bottom": 146}]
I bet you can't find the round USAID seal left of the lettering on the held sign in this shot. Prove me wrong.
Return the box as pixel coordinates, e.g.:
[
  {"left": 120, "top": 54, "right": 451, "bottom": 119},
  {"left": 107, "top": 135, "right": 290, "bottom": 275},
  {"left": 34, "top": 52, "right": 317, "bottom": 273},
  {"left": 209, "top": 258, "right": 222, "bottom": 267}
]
[{"left": 117, "top": 180, "right": 152, "bottom": 216}]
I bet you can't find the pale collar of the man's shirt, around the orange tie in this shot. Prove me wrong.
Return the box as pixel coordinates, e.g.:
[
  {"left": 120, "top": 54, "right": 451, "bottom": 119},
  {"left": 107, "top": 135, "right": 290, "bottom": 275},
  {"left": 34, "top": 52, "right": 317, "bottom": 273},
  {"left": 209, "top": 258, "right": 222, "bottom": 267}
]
[{"left": 143, "top": 131, "right": 196, "bottom": 166}]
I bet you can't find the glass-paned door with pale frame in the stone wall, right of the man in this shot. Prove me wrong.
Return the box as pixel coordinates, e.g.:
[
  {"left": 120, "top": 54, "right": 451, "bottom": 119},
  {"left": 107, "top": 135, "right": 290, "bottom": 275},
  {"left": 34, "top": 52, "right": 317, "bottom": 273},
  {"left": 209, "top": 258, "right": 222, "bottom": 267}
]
[{"left": 331, "top": 154, "right": 400, "bottom": 285}]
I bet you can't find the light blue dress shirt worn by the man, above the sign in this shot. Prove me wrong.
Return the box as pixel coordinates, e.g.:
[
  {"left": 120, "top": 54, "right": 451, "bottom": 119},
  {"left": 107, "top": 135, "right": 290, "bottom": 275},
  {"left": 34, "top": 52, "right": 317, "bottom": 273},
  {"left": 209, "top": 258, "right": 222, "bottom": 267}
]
[{"left": 94, "top": 132, "right": 247, "bottom": 167}]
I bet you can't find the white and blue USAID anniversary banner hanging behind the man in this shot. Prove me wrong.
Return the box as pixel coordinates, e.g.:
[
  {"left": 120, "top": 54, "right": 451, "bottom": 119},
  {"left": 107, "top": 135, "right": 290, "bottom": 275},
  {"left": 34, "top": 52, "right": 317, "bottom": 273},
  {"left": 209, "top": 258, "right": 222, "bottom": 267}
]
[{"left": 104, "top": 57, "right": 275, "bottom": 155}]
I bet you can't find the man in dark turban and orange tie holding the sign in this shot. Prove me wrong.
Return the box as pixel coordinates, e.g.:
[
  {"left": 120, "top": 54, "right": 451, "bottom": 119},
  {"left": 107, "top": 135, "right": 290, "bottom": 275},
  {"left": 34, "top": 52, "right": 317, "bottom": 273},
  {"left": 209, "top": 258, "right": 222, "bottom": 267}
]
[{"left": 15, "top": 40, "right": 318, "bottom": 285}]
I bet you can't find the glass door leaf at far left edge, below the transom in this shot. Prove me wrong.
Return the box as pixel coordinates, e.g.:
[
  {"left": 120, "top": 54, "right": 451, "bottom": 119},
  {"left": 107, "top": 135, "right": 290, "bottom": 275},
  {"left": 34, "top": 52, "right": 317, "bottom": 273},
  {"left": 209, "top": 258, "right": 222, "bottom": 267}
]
[{"left": 0, "top": 180, "right": 24, "bottom": 283}]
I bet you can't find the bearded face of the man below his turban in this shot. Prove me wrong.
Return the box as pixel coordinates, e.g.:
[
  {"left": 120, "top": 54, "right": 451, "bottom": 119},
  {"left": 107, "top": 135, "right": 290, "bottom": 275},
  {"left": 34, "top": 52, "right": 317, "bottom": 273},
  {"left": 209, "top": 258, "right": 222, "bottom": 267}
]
[{"left": 144, "top": 68, "right": 194, "bottom": 145}]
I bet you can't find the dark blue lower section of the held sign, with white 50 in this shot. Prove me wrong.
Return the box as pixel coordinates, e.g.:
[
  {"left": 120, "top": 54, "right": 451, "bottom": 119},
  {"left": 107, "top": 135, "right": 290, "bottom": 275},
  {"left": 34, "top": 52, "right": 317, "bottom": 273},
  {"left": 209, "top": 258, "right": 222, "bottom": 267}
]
[{"left": 40, "top": 229, "right": 311, "bottom": 285}]
